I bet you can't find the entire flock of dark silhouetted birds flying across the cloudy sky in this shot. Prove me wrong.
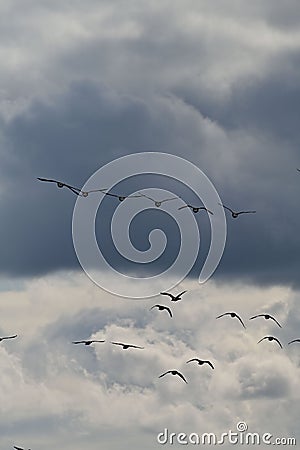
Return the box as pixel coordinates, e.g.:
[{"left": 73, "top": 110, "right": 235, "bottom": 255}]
[{"left": 6, "top": 174, "right": 300, "bottom": 450}]
